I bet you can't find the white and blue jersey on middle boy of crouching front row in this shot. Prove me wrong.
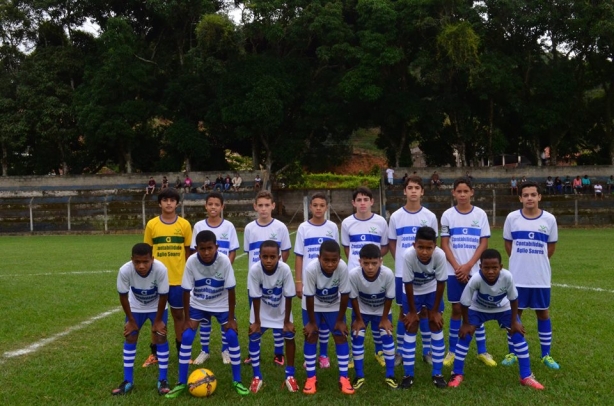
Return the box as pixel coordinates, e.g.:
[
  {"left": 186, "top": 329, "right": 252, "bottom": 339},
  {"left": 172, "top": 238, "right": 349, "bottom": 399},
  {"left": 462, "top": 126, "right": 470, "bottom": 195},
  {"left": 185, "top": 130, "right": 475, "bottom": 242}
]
[{"left": 301, "top": 260, "right": 351, "bottom": 312}]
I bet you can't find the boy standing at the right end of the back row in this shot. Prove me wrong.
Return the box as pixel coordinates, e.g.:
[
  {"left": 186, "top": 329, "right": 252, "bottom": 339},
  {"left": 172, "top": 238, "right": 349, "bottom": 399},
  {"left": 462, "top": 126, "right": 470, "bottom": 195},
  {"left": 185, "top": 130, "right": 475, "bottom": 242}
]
[{"left": 503, "top": 182, "right": 559, "bottom": 369}]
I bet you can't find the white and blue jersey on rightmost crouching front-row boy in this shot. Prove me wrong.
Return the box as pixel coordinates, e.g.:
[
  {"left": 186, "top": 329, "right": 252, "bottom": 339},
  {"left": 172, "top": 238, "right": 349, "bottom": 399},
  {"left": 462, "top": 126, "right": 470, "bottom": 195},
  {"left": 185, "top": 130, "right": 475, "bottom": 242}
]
[{"left": 460, "top": 269, "right": 518, "bottom": 313}]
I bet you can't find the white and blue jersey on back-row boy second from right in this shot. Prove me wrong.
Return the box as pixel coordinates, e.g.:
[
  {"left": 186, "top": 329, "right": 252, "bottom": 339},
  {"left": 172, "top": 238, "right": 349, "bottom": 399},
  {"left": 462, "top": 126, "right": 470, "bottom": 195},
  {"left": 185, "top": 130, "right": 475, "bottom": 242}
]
[{"left": 441, "top": 206, "right": 490, "bottom": 276}]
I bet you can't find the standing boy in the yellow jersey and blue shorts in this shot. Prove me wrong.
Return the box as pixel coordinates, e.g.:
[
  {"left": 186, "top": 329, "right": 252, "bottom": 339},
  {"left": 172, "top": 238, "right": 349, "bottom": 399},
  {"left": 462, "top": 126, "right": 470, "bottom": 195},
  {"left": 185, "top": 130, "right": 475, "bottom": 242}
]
[{"left": 143, "top": 188, "right": 192, "bottom": 367}]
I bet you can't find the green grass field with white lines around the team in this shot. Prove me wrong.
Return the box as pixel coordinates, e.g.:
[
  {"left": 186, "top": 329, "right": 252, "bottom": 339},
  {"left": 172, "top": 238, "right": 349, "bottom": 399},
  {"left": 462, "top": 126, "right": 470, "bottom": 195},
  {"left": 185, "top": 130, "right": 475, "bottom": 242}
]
[{"left": 0, "top": 229, "right": 614, "bottom": 405}]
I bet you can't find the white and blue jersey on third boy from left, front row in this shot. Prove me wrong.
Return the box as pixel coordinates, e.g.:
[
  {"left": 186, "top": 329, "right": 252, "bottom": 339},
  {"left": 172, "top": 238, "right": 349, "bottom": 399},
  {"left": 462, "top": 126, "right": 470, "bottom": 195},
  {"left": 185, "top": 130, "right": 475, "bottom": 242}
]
[{"left": 247, "top": 261, "right": 296, "bottom": 328}]
